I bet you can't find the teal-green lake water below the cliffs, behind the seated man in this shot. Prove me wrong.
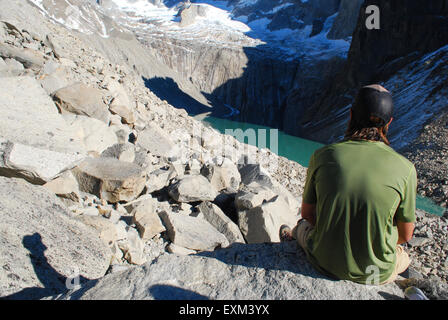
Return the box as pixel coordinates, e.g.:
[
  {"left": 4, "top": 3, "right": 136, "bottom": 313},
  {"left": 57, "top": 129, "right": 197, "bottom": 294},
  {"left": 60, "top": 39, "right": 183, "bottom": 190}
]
[{"left": 202, "top": 117, "right": 445, "bottom": 216}]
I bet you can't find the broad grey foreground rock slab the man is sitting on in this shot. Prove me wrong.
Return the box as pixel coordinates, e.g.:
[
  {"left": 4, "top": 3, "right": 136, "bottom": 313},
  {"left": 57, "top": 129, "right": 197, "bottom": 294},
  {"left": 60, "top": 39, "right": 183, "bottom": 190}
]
[{"left": 55, "top": 241, "right": 404, "bottom": 300}]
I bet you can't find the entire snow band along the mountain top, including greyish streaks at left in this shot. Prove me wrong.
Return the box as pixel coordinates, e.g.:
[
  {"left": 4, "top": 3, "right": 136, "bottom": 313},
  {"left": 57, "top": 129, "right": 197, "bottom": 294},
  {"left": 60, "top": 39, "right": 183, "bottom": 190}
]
[{"left": 29, "top": 0, "right": 350, "bottom": 59}]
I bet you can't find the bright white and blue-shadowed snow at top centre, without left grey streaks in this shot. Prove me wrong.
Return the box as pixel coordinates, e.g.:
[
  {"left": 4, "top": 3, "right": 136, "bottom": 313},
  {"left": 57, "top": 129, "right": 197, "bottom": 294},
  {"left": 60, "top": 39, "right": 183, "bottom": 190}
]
[{"left": 107, "top": 0, "right": 350, "bottom": 59}]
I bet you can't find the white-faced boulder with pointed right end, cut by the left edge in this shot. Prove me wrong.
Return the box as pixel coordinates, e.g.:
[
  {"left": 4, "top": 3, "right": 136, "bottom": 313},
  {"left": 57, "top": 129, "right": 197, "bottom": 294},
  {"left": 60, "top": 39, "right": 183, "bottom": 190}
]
[{"left": 0, "top": 138, "right": 84, "bottom": 184}]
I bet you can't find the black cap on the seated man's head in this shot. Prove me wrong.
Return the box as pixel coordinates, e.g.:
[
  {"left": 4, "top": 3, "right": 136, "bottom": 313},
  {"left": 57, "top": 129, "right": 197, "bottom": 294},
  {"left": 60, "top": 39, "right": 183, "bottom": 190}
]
[{"left": 352, "top": 85, "right": 394, "bottom": 127}]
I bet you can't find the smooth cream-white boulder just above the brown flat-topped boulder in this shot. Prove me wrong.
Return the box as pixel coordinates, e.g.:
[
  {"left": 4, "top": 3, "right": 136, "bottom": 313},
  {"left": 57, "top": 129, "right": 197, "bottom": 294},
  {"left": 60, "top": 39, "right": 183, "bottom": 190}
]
[{"left": 63, "top": 114, "right": 118, "bottom": 155}]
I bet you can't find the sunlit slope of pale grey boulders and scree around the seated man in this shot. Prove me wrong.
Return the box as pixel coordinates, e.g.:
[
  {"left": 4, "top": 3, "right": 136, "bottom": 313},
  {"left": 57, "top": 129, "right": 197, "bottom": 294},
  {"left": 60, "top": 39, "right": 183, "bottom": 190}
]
[{"left": 0, "top": 0, "right": 447, "bottom": 299}]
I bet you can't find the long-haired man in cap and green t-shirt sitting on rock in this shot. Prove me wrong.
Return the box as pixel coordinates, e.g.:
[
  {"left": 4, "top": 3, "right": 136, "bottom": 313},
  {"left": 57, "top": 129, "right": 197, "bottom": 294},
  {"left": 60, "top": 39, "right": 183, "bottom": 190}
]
[{"left": 280, "top": 85, "right": 417, "bottom": 285}]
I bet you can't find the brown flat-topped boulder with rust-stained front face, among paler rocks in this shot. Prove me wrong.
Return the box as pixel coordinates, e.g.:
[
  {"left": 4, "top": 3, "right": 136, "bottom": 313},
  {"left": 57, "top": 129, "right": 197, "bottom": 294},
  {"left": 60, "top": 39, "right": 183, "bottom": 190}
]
[{"left": 72, "top": 158, "right": 146, "bottom": 203}]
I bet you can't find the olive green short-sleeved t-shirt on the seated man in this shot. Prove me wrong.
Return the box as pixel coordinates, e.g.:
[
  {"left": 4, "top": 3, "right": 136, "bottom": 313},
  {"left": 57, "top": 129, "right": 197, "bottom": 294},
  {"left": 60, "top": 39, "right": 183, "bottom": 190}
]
[{"left": 303, "top": 140, "right": 417, "bottom": 283}]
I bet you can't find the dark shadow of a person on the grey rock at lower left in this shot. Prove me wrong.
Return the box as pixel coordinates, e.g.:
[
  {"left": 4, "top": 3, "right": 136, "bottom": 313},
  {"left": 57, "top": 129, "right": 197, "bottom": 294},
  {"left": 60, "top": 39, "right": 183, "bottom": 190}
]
[{"left": 2, "top": 233, "right": 89, "bottom": 300}]
